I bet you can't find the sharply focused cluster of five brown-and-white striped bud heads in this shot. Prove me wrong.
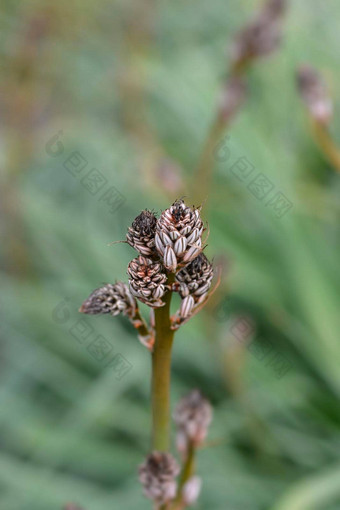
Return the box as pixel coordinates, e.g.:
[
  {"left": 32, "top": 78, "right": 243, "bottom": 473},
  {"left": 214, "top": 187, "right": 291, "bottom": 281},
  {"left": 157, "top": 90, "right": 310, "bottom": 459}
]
[{"left": 80, "top": 199, "right": 213, "bottom": 327}]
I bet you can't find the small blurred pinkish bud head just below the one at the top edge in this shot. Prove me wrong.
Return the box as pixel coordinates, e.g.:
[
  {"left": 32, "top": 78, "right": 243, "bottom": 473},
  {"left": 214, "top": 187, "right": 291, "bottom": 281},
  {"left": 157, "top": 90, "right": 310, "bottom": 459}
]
[{"left": 218, "top": 76, "right": 246, "bottom": 122}]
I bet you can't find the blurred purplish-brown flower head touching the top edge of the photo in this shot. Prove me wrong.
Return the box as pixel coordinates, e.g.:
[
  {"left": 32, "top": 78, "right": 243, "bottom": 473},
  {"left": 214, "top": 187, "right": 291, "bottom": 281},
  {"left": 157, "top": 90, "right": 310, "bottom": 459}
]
[{"left": 231, "top": 0, "right": 286, "bottom": 65}]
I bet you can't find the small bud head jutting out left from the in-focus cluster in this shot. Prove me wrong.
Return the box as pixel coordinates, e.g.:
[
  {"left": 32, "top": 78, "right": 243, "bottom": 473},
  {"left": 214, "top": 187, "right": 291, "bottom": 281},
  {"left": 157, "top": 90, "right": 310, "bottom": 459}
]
[{"left": 79, "top": 282, "right": 136, "bottom": 317}]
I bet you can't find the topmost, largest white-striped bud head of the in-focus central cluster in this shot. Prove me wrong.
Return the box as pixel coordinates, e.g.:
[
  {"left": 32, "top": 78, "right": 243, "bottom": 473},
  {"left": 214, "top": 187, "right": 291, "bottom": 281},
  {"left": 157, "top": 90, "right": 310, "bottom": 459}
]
[{"left": 155, "top": 200, "right": 204, "bottom": 272}]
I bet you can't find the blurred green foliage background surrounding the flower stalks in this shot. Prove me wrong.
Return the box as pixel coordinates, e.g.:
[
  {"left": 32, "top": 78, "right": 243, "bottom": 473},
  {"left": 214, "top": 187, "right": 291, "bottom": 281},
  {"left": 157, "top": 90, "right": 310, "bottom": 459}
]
[{"left": 0, "top": 0, "right": 340, "bottom": 510}]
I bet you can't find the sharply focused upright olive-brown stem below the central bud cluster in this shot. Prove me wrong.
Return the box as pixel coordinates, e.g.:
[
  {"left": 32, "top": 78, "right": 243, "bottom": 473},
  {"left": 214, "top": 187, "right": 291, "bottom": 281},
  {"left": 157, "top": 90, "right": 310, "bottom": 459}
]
[{"left": 151, "top": 274, "right": 174, "bottom": 452}]
